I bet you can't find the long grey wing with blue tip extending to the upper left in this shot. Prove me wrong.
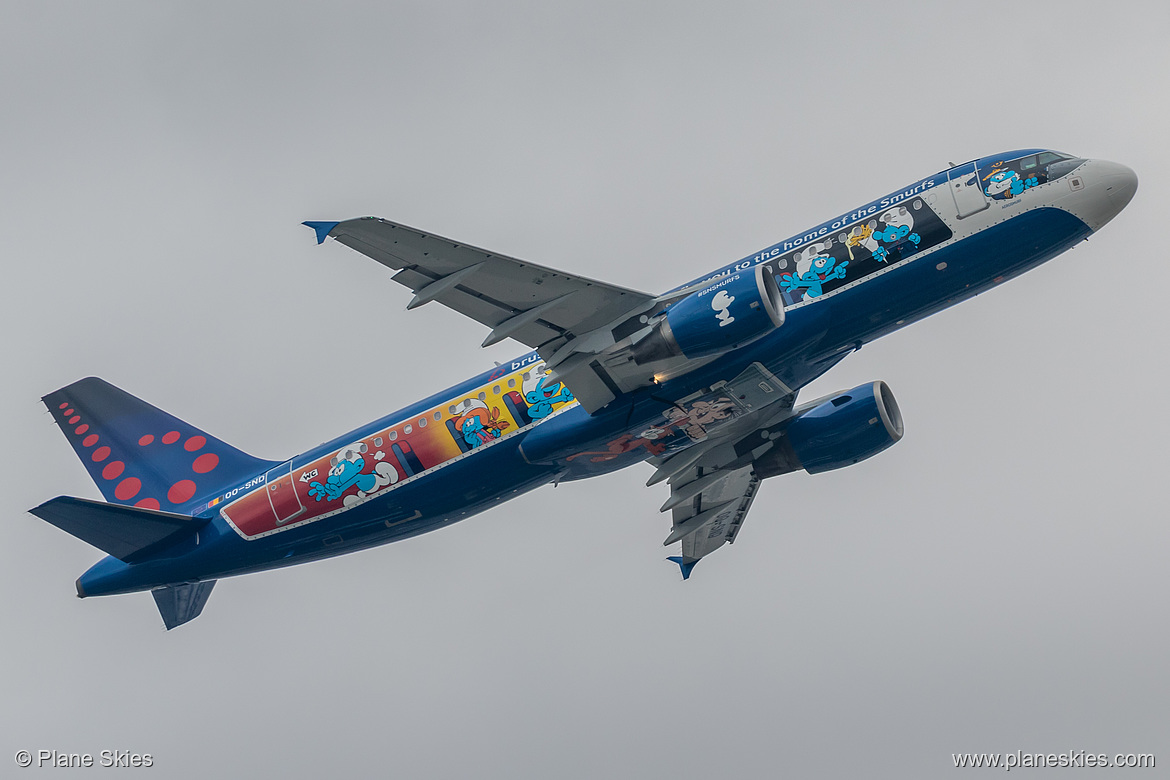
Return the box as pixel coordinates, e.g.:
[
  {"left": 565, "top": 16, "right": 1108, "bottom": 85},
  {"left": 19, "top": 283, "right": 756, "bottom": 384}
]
[{"left": 305, "top": 216, "right": 659, "bottom": 413}]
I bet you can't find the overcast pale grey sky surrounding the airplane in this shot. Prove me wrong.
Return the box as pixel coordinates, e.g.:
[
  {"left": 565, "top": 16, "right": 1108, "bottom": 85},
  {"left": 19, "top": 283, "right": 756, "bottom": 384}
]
[{"left": 0, "top": 0, "right": 1170, "bottom": 780}]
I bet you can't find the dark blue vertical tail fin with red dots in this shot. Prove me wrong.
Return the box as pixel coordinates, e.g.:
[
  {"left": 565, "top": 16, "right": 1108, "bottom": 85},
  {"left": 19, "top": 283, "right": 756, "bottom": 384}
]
[{"left": 41, "top": 377, "right": 276, "bottom": 512}]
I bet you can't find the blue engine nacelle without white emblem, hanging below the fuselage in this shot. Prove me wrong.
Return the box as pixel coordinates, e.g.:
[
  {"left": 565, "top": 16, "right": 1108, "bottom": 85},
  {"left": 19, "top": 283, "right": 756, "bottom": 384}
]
[{"left": 753, "top": 381, "right": 903, "bottom": 478}]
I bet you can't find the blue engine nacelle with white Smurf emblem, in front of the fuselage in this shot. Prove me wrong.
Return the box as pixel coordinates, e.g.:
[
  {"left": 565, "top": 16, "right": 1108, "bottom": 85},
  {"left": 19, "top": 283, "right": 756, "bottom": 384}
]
[{"left": 633, "top": 265, "right": 784, "bottom": 365}]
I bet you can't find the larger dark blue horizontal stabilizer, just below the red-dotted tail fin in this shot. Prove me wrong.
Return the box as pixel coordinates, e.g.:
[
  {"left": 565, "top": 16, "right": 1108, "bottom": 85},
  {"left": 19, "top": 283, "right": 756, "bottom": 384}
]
[{"left": 28, "top": 496, "right": 207, "bottom": 564}]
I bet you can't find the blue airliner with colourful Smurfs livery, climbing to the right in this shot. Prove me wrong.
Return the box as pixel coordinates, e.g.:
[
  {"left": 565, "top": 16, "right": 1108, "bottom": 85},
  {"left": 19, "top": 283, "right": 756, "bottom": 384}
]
[{"left": 29, "top": 149, "right": 1137, "bottom": 630}]
